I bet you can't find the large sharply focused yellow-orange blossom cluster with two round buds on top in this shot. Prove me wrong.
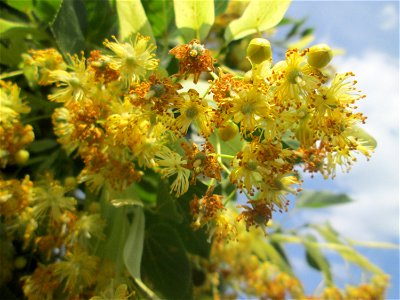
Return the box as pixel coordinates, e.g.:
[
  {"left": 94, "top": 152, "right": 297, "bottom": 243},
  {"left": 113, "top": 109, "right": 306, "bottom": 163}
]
[{"left": 21, "top": 35, "right": 372, "bottom": 233}]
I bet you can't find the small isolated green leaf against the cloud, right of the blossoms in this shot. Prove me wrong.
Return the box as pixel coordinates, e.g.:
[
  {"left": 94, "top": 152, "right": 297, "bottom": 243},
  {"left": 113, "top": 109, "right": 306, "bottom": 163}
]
[{"left": 296, "top": 191, "right": 353, "bottom": 208}]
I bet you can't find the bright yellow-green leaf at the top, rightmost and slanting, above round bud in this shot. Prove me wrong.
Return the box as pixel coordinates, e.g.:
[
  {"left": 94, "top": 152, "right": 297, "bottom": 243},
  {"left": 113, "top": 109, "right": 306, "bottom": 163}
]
[{"left": 224, "top": 0, "right": 290, "bottom": 43}]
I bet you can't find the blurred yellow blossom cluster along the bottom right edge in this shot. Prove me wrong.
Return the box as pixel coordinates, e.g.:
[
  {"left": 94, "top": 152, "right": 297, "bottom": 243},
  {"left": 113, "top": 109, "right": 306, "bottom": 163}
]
[{"left": 195, "top": 221, "right": 389, "bottom": 300}]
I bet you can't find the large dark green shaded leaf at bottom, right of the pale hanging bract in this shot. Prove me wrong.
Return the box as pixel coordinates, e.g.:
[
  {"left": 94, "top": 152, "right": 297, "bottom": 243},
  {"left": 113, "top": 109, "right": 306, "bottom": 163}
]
[{"left": 142, "top": 223, "right": 192, "bottom": 299}]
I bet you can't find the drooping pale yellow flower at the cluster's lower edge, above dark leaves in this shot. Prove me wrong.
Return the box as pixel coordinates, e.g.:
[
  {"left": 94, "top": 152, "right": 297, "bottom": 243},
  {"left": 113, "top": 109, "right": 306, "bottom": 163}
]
[{"left": 156, "top": 147, "right": 190, "bottom": 197}]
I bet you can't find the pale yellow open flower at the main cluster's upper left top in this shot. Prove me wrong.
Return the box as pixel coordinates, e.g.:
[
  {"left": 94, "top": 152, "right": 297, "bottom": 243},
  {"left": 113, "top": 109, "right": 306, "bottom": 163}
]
[{"left": 104, "top": 34, "right": 158, "bottom": 86}]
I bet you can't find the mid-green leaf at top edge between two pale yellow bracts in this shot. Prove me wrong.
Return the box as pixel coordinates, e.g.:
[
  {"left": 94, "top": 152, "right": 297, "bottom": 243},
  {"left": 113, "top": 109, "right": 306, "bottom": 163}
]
[{"left": 143, "top": 0, "right": 174, "bottom": 37}]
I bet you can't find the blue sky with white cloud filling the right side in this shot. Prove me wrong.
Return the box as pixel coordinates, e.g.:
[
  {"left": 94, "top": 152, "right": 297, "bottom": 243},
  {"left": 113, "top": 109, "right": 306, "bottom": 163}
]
[{"left": 286, "top": 1, "right": 400, "bottom": 299}]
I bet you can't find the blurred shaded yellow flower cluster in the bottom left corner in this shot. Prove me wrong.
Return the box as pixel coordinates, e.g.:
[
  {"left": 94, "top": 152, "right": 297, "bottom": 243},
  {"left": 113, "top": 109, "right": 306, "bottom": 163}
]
[{"left": 0, "top": 174, "right": 111, "bottom": 300}]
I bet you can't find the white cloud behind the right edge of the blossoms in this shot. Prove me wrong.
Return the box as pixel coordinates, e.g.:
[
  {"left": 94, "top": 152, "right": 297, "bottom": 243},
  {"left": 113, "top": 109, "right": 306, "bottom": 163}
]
[{"left": 304, "top": 52, "right": 399, "bottom": 241}]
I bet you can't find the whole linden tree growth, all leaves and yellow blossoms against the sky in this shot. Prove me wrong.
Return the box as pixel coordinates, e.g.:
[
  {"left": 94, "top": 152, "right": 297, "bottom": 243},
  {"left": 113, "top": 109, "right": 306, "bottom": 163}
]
[{"left": 0, "top": 0, "right": 396, "bottom": 299}]
